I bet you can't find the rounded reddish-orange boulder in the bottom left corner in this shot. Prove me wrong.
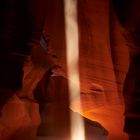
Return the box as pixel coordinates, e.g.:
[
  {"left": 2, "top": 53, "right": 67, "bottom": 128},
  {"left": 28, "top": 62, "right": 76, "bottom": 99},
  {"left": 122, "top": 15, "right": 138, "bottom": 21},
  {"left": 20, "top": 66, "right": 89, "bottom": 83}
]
[{"left": 0, "top": 96, "right": 40, "bottom": 140}]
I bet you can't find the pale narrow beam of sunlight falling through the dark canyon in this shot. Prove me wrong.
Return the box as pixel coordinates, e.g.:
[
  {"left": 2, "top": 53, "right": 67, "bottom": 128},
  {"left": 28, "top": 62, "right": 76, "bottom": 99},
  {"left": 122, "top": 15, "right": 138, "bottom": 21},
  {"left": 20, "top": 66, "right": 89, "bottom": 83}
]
[{"left": 64, "top": 0, "right": 85, "bottom": 140}]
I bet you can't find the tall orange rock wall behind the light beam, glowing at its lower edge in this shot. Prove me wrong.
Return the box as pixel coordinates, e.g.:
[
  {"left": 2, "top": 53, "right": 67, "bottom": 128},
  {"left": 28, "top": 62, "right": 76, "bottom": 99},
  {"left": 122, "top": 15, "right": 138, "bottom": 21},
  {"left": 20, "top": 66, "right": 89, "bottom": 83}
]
[{"left": 45, "top": 0, "right": 129, "bottom": 140}]
